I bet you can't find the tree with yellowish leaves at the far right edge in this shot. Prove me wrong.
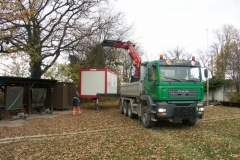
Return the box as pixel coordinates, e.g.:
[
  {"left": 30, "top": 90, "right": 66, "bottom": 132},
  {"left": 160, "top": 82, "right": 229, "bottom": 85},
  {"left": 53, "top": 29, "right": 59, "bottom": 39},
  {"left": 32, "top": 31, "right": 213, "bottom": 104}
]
[{"left": 206, "top": 25, "right": 240, "bottom": 101}]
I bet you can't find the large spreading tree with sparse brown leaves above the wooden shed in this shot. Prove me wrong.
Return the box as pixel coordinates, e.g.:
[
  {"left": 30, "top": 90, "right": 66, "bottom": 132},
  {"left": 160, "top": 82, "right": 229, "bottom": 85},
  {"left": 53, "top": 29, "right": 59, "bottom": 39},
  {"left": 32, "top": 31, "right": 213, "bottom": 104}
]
[{"left": 0, "top": 0, "right": 105, "bottom": 78}]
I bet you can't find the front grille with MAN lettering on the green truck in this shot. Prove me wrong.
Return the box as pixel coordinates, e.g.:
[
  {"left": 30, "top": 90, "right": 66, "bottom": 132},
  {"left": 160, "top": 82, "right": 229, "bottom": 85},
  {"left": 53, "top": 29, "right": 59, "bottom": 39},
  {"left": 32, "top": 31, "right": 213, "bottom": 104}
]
[{"left": 168, "top": 89, "right": 197, "bottom": 98}]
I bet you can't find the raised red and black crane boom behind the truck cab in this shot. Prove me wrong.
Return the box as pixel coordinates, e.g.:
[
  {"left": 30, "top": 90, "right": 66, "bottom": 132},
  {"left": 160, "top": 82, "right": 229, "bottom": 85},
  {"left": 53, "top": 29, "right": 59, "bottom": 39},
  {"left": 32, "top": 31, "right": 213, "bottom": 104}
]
[{"left": 102, "top": 40, "right": 141, "bottom": 76}]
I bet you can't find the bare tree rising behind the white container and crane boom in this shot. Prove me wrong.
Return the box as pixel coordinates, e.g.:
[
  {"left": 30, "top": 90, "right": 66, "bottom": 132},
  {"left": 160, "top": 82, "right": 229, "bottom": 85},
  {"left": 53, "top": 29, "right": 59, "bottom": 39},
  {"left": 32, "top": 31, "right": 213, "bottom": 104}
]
[{"left": 63, "top": 6, "right": 138, "bottom": 85}]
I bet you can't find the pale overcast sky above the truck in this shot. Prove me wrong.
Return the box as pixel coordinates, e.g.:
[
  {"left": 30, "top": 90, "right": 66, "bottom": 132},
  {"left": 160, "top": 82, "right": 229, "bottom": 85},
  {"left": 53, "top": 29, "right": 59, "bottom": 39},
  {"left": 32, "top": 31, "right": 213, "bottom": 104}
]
[{"left": 115, "top": 0, "right": 240, "bottom": 60}]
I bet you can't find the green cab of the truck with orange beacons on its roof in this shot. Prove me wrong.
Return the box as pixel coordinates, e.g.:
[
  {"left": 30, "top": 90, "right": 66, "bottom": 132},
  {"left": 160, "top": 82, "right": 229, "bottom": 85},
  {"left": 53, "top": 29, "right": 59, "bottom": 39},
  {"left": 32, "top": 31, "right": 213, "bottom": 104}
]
[{"left": 142, "top": 57, "right": 204, "bottom": 125}]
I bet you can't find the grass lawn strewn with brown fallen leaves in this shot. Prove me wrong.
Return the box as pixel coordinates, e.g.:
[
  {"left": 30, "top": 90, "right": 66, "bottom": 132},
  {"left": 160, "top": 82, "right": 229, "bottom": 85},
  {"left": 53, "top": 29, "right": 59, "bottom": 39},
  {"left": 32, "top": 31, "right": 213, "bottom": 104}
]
[{"left": 0, "top": 102, "right": 240, "bottom": 160}]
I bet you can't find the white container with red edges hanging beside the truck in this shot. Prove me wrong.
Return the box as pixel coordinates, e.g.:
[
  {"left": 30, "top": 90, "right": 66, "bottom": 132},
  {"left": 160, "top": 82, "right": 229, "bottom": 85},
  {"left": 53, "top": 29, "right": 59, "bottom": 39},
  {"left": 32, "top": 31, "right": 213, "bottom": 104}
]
[{"left": 79, "top": 68, "right": 117, "bottom": 98}]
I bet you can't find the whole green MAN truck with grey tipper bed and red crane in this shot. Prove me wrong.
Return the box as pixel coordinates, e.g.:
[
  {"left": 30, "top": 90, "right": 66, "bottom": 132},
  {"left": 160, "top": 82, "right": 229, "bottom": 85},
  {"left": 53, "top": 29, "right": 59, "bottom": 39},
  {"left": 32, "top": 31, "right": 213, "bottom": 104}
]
[{"left": 102, "top": 40, "right": 208, "bottom": 128}]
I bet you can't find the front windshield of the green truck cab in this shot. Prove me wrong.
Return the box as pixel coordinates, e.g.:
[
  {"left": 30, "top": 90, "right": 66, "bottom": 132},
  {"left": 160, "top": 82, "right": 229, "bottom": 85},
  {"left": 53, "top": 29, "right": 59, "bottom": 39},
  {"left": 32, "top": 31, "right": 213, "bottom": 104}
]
[{"left": 160, "top": 66, "right": 201, "bottom": 82}]
